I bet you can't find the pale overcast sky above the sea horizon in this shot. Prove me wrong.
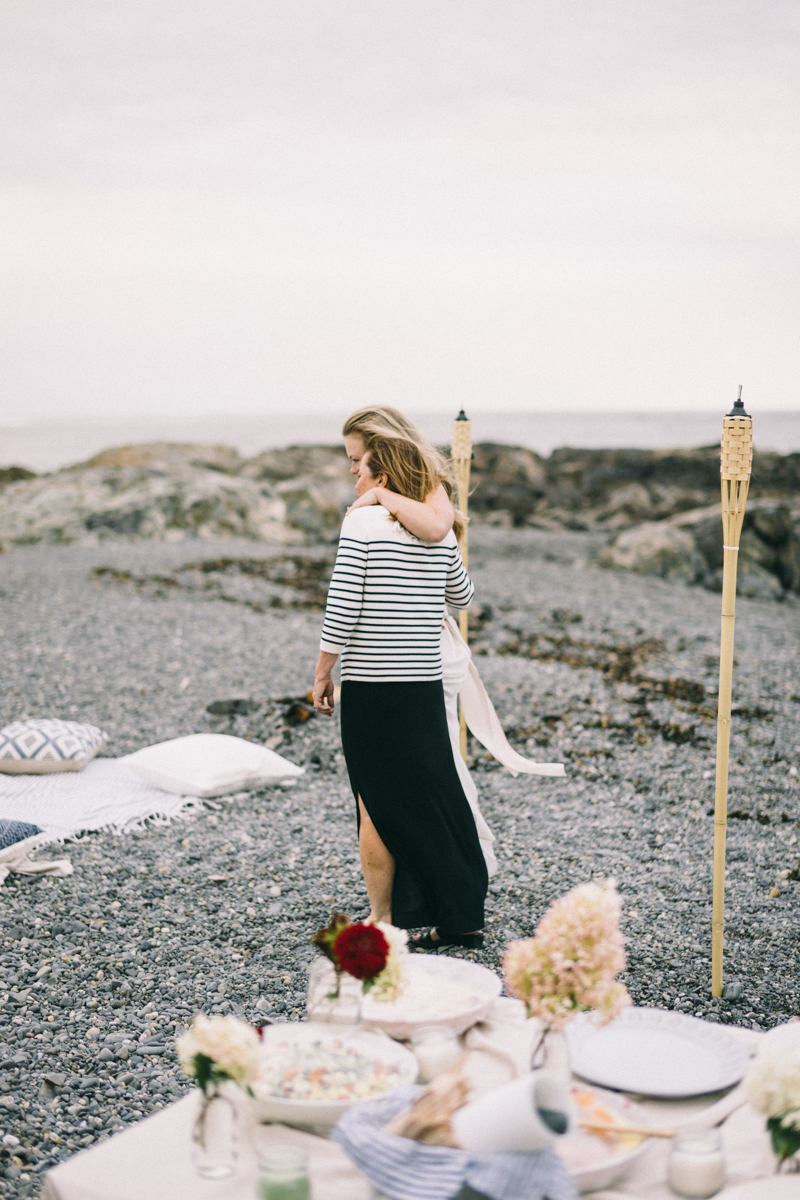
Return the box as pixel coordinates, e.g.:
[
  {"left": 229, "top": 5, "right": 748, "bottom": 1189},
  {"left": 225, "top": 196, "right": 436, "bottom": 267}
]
[{"left": 0, "top": 0, "right": 800, "bottom": 424}]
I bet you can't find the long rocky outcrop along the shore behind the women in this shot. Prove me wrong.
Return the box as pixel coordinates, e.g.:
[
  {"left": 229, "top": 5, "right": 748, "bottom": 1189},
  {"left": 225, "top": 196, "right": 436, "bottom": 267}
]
[{"left": 0, "top": 442, "right": 800, "bottom": 596}]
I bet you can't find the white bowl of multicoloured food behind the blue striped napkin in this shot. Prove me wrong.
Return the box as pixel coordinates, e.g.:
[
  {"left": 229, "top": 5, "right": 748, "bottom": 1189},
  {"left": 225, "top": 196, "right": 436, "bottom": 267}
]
[{"left": 252, "top": 1021, "right": 417, "bottom": 1129}]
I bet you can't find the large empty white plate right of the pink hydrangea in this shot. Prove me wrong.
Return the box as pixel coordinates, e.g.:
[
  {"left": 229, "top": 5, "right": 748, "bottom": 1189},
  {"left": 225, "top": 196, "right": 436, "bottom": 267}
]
[{"left": 566, "top": 1008, "right": 750, "bottom": 1097}]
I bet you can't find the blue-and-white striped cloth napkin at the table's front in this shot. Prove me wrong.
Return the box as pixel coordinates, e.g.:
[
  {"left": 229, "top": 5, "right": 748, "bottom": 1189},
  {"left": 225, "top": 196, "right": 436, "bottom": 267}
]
[{"left": 331, "top": 1087, "right": 578, "bottom": 1200}]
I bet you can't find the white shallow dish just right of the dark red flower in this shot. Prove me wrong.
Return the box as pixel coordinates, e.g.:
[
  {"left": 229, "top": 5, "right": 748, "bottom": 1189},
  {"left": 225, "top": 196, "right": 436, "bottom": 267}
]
[{"left": 361, "top": 954, "right": 503, "bottom": 1039}]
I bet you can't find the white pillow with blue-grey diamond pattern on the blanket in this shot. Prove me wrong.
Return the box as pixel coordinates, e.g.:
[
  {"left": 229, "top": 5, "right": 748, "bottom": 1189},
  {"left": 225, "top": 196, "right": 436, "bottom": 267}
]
[{"left": 0, "top": 718, "right": 108, "bottom": 775}]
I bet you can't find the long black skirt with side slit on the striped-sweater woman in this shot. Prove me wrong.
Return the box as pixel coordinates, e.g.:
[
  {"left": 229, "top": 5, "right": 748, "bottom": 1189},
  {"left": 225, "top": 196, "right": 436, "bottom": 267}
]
[{"left": 342, "top": 679, "right": 488, "bottom": 934}]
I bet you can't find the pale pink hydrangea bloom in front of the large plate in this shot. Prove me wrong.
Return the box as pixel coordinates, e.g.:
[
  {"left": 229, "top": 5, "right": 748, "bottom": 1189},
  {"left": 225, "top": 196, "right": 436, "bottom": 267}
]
[{"left": 503, "top": 880, "right": 631, "bottom": 1030}]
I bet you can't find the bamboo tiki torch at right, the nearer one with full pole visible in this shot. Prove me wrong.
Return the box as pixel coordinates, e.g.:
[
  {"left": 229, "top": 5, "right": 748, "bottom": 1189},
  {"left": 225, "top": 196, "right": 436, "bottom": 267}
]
[{"left": 711, "top": 388, "right": 753, "bottom": 996}]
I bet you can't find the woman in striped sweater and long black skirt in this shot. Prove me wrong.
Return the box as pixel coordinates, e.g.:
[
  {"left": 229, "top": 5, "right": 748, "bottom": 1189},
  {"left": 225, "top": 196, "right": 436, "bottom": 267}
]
[{"left": 314, "top": 434, "right": 488, "bottom": 949}]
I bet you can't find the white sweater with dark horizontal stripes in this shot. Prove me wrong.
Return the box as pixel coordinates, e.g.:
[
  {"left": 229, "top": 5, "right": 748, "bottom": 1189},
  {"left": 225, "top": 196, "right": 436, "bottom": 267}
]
[{"left": 320, "top": 504, "right": 474, "bottom": 682}]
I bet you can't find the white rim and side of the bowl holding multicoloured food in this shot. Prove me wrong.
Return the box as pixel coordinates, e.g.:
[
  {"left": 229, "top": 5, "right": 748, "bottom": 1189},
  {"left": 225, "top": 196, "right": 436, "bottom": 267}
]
[{"left": 253, "top": 1021, "right": 417, "bottom": 1129}]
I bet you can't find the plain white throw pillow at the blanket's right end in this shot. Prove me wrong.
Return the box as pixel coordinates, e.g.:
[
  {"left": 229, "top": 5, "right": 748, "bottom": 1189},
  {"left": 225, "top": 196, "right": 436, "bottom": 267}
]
[{"left": 121, "top": 733, "right": 305, "bottom": 797}]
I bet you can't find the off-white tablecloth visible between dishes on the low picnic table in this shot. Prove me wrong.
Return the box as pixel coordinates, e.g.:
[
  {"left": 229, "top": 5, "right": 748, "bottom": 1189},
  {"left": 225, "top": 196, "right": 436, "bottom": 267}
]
[{"left": 42, "top": 1027, "right": 782, "bottom": 1200}]
